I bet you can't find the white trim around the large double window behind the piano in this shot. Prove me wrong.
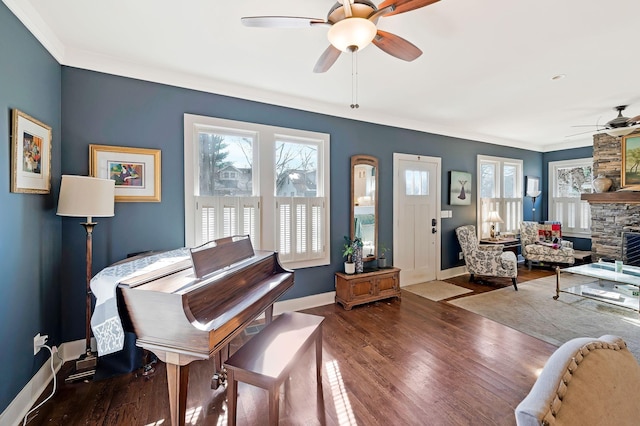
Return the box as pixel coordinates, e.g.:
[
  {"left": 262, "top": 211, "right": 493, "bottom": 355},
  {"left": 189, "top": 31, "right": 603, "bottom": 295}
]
[{"left": 184, "top": 114, "right": 331, "bottom": 269}]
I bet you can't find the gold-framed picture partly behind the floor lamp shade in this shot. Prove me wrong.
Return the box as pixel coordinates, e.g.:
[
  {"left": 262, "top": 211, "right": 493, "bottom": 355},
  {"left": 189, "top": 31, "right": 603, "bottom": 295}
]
[{"left": 89, "top": 145, "right": 161, "bottom": 202}]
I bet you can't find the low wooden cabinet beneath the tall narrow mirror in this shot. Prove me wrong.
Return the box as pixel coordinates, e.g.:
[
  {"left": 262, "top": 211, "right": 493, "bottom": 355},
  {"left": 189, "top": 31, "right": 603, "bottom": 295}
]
[{"left": 335, "top": 267, "right": 400, "bottom": 310}]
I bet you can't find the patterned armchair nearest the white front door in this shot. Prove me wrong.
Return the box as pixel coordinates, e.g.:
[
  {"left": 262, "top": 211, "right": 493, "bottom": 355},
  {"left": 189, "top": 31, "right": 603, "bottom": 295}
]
[{"left": 456, "top": 225, "right": 518, "bottom": 290}]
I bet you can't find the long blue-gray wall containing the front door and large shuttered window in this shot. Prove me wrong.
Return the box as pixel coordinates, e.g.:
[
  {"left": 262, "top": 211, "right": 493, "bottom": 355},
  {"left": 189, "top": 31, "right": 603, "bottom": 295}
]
[{"left": 62, "top": 67, "right": 542, "bottom": 306}]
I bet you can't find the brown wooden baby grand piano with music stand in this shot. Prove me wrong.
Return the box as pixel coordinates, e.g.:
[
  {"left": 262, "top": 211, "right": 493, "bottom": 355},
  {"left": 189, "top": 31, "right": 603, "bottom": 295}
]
[{"left": 117, "top": 237, "right": 293, "bottom": 426}]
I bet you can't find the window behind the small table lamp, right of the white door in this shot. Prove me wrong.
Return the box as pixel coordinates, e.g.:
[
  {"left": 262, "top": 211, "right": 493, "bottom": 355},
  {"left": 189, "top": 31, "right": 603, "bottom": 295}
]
[{"left": 478, "top": 155, "right": 523, "bottom": 238}]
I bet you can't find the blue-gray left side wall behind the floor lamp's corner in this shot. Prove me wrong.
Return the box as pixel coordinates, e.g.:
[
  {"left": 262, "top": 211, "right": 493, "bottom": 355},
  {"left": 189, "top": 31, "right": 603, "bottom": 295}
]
[{"left": 0, "top": 2, "right": 62, "bottom": 412}]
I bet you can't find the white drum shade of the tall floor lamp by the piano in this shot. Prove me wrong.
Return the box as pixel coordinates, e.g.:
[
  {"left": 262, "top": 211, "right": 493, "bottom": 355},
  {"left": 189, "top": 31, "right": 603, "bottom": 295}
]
[{"left": 57, "top": 175, "right": 116, "bottom": 218}]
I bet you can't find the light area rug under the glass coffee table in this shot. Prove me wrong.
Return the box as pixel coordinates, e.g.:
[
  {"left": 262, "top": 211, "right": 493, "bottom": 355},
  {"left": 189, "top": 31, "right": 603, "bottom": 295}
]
[{"left": 446, "top": 274, "right": 640, "bottom": 360}]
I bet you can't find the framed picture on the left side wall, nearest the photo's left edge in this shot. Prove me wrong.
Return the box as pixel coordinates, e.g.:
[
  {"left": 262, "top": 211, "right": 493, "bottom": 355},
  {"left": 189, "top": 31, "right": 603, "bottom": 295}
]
[{"left": 11, "top": 109, "right": 51, "bottom": 194}]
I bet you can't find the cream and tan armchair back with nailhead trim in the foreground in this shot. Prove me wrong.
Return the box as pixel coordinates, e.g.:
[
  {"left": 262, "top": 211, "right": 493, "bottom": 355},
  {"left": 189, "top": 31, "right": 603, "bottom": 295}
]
[{"left": 515, "top": 335, "right": 640, "bottom": 426}]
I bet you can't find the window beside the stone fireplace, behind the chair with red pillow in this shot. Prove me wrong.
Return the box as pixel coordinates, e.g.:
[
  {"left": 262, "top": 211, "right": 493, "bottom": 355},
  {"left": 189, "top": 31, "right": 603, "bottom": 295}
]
[{"left": 549, "top": 158, "right": 593, "bottom": 238}]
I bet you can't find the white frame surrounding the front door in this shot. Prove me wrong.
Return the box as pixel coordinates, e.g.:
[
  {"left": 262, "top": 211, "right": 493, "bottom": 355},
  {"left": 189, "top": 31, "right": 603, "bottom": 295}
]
[{"left": 393, "top": 152, "right": 442, "bottom": 287}]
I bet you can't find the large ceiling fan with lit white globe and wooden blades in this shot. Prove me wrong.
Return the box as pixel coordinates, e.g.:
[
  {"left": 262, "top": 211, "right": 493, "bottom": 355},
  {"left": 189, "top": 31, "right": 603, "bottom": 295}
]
[{"left": 241, "top": 0, "right": 439, "bottom": 73}]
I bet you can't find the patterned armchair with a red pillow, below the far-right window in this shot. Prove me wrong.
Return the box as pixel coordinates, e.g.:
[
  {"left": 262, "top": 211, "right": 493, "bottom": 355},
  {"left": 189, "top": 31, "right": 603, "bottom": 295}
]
[{"left": 520, "top": 222, "right": 576, "bottom": 269}]
